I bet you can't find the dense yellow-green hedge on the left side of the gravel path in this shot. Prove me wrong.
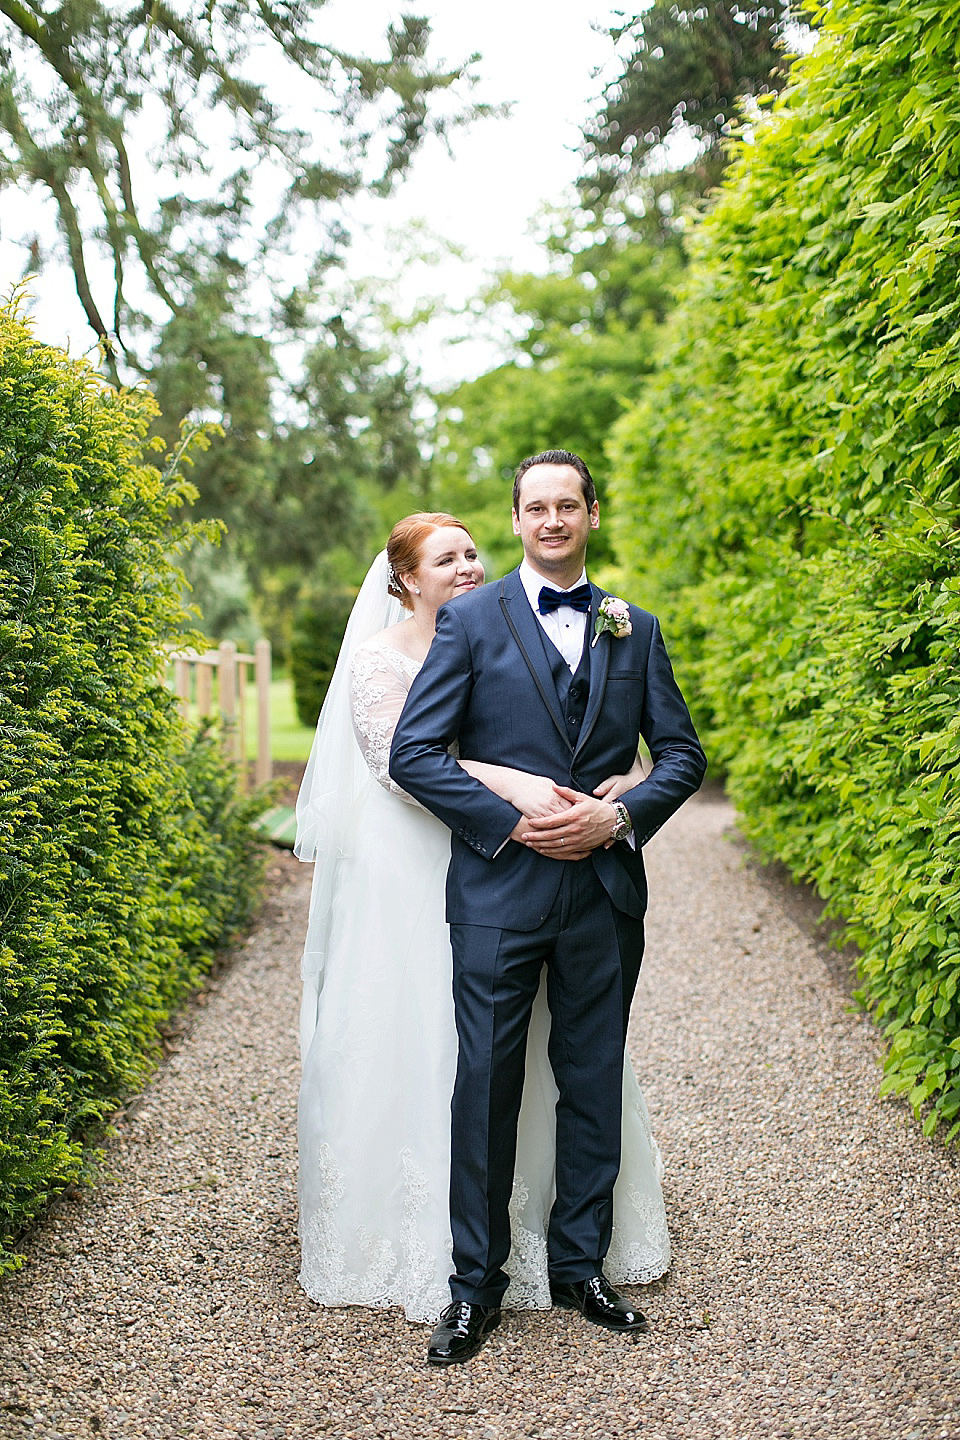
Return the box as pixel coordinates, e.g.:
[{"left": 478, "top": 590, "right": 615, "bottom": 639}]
[{"left": 0, "top": 300, "right": 264, "bottom": 1270}]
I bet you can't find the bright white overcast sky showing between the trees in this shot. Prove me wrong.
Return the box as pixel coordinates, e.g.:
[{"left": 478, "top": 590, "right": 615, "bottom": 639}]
[{"left": 0, "top": 0, "right": 627, "bottom": 383}]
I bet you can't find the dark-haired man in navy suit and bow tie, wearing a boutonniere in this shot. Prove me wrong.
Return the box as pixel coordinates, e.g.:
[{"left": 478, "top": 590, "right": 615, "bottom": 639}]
[{"left": 390, "top": 451, "right": 707, "bottom": 1365}]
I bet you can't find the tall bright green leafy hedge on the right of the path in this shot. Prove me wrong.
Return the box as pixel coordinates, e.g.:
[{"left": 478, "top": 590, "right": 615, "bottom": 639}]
[{"left": 610, "top": 0, "right": 960, "bottom": 1138}]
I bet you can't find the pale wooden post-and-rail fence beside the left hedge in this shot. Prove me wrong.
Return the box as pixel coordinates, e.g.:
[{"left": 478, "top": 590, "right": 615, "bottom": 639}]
[{"left": 167, "top": 639, "right": 273, "bottom": 786}]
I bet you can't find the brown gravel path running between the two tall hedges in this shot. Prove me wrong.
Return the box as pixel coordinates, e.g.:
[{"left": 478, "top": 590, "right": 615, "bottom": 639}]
[{"left": 0, "top": 796, "right": 960, "bottom": 1440}]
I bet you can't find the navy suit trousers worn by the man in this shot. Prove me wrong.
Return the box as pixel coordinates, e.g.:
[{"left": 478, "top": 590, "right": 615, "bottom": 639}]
[{"left": 450, "top": 860, "right": 643, "bottom": 1305}]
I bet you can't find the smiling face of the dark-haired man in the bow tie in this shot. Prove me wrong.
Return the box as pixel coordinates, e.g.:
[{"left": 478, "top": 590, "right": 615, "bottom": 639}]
[{"left": 514, "top": 465, "right": 600, "bottom": 586}]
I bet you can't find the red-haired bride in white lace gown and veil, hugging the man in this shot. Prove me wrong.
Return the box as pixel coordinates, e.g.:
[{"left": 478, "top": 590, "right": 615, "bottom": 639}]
[{"left": 296, "top": 514, "right": 669, "bottom": 1322}]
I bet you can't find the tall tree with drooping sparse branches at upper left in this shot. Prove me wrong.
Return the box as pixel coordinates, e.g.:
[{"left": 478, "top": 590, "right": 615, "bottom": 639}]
[{"left": 0, "top": 0, "right": 484, "bottom": 648}]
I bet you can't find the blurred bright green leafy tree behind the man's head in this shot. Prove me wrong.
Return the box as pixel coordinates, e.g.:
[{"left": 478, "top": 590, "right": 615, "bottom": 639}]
[{"left": 432, "top": 217, "right": 681, "bottom": 569}]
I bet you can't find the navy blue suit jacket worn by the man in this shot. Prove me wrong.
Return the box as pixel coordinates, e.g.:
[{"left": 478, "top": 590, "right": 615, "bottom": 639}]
[{"left": 390, "top": 570, "right": 707, "bottom": 930}]
